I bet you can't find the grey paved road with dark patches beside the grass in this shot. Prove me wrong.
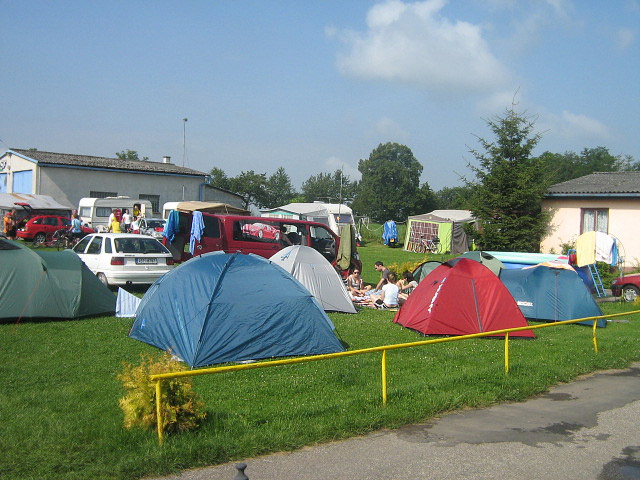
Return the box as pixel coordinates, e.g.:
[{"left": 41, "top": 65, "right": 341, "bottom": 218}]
[{"left": 154, "top": 363, "right": 640, "bottom": 480}]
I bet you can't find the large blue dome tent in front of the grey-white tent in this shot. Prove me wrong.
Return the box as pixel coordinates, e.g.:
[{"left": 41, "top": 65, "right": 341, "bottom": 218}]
[{"left": 129, "top": 252, "right": 344, "bottom": 367}]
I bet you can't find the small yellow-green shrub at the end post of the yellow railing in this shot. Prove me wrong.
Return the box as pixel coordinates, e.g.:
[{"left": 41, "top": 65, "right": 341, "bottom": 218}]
[{"left": 118, "top": 353, "right": 206, "bottom": 433}]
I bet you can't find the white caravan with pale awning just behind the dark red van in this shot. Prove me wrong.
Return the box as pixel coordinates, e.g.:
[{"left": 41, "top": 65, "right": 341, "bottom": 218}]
[{"left": 262, "top": 202, "right": 355, "bottom": 235}]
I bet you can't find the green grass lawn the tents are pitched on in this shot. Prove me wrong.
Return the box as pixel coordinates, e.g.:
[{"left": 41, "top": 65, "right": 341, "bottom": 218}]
[{"left": 0, "top": 244, "right": 640, "bottom": 479}]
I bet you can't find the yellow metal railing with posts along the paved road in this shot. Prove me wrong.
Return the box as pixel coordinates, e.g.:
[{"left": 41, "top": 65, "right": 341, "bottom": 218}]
[{"left": 149, "top": 310, "right": 640, "bottom": 443}]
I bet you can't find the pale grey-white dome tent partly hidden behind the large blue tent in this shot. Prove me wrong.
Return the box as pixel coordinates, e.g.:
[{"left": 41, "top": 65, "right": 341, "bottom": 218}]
[{"left": 269, "top": 245, "right": 356, "bottom": 313}]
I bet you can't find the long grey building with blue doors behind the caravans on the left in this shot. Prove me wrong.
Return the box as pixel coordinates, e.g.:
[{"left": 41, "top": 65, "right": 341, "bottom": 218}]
[{"left": 0, "top": 148, "right": 243, "bottom": 214}]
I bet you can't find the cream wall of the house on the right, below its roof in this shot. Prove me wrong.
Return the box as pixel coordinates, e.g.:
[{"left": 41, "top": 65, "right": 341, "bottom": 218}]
[{"left": 540, "top": 198, "right": 640, "bottom": 268}]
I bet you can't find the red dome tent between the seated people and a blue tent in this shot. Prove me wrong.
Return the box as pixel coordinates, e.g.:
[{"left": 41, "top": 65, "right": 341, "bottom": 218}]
[{"left": 393, "top": 258, "right": 535, "bottom": 338}]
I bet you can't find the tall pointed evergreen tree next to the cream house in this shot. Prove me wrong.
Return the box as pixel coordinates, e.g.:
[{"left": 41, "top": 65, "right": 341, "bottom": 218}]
[{"left": 469, "top": 108, "right": 550, "bottom": 252}]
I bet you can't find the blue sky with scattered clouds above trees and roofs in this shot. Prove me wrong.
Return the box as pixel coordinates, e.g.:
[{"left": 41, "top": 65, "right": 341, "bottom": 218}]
[{"left": 0, "top": 0, "right": 640, "bottom": 190}]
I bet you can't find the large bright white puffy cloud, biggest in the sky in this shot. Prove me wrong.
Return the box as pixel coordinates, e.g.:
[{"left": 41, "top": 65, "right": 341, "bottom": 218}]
[{"left": 338, "top": 0, "right": 510, "bottom": 94}]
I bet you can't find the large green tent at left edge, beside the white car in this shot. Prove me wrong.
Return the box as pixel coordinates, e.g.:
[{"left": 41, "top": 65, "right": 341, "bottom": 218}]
[{"left": 0, "top": 239, "right": 116, "bottom": 319}]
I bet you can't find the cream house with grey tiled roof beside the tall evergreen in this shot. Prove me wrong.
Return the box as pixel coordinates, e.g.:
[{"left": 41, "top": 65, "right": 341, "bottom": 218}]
[{"left": 540, "top": 172, "right": 640, "bottom": 269}]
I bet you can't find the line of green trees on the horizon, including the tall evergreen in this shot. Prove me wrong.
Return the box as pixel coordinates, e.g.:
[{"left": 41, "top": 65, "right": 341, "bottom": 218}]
[{"left": 118, "top": 107, "right": 640, "bottom": 251}]
